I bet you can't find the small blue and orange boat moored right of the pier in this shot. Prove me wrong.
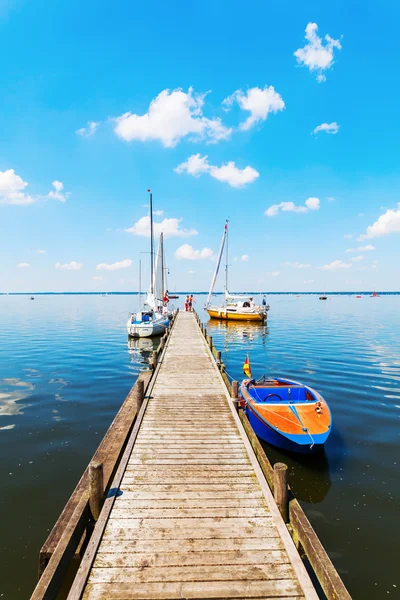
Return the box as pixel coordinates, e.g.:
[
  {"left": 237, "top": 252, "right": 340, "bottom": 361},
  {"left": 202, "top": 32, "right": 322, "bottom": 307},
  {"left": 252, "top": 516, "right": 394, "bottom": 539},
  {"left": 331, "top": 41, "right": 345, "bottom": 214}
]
[{"left": 240, "top": 377, "right": 332, "bottom": 453}]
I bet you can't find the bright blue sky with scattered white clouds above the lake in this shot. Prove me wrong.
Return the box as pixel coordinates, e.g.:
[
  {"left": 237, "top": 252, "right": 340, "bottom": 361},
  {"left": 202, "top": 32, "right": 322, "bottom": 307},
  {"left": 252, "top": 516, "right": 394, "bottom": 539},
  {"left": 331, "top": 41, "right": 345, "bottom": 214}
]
[{"left": 0, "top": 0, "right": 400, "bottom": 291}]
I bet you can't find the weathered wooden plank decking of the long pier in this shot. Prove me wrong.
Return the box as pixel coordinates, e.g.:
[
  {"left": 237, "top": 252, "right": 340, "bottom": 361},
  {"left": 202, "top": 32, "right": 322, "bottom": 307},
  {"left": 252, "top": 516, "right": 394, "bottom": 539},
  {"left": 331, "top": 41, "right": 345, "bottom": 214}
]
[{"left": 70, "top": 313, "right": 317, "bottom": 600}]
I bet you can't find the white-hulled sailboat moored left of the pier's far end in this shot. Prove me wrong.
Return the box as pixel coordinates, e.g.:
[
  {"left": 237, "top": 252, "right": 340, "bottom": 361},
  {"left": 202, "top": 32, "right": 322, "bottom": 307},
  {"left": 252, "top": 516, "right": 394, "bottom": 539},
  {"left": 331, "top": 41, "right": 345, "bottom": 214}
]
[{"left": 126, "top": 193, "right": 169, "bottom": 337}]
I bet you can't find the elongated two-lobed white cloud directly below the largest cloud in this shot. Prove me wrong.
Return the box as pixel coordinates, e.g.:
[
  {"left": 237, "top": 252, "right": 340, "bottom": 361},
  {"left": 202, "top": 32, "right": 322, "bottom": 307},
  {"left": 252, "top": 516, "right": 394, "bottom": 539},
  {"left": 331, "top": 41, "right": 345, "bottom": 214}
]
[{"left": 174, "top": 154, "right": 260, "bottom": 188}]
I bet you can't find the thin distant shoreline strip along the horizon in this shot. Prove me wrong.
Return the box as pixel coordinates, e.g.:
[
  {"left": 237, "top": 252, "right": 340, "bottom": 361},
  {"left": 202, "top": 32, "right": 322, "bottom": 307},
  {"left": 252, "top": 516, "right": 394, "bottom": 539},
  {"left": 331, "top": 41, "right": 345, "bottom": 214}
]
[{"left": 0, "top": 290, "right": 400, "bottom": 296}]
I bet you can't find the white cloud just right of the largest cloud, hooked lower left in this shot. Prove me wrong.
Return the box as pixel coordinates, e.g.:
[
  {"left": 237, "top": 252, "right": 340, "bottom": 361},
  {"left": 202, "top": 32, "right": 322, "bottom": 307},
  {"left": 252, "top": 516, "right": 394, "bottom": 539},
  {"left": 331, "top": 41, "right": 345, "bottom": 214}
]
[{"left": 222, "top": 85, "right": 285, "bottom": 131}]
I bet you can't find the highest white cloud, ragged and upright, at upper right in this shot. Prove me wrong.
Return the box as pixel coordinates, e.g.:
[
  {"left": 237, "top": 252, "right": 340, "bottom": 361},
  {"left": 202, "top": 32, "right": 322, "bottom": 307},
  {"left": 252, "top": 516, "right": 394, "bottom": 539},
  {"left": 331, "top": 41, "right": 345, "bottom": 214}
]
[{"left": 294, "top": 23, "right": 342, "bottom": 83}]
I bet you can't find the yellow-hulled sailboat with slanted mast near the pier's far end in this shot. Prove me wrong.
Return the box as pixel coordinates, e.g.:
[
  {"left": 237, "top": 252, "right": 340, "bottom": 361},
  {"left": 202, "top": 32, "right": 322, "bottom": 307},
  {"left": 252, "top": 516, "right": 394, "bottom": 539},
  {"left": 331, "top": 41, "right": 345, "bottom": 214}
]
[{"left": 205, "top": 221, "right": 269, "bottom": 323}]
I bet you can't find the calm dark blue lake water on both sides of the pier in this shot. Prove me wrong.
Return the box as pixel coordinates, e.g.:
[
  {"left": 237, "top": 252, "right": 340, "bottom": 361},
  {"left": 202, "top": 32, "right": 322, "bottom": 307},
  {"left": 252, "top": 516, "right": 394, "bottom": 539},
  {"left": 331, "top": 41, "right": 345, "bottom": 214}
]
[{"left": 0, "top": 295, "right": 400, "bottom": 600}]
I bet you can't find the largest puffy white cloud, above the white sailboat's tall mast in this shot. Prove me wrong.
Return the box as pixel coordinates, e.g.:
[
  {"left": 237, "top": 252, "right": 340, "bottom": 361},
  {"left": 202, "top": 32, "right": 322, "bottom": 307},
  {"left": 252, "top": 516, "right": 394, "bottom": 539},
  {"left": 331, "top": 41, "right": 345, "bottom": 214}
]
[{"left": 114, "top": 88, "right": 232, "bottom": 148}]
